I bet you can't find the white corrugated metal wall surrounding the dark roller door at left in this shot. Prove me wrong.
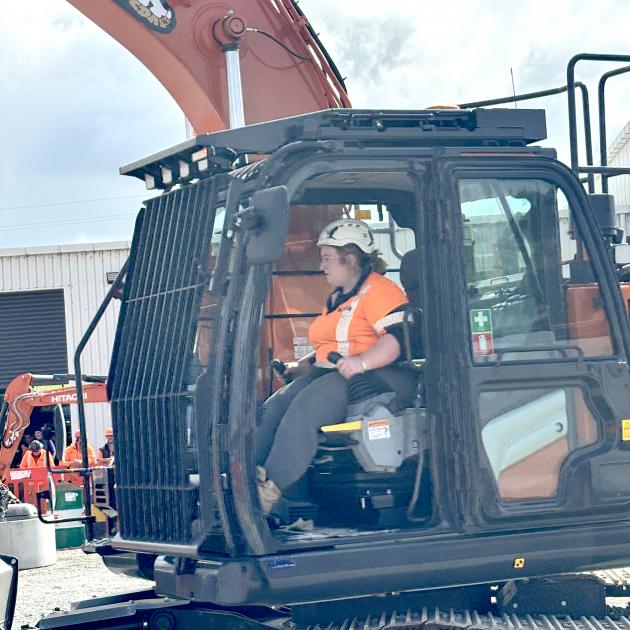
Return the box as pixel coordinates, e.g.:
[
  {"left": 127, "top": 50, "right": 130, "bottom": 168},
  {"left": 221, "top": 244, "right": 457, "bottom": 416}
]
[{"left": 0, "top": 242, "right": 130, "bottom": 448}]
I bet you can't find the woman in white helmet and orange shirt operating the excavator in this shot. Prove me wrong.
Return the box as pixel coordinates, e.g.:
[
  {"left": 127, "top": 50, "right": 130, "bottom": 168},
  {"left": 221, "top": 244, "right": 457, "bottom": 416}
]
[{"left": 255, "top": 219, "right": 416, "bottom": 514}]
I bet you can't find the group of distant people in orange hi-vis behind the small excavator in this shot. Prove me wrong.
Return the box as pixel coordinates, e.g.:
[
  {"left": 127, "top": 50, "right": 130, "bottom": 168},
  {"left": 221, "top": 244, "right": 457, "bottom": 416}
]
[{"left": 11, "top": 427, "right": 114, "bottom": 468}]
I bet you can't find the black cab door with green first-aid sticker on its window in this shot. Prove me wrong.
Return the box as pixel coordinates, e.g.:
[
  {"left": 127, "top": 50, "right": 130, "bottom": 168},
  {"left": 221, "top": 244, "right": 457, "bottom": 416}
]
[{"left": 441, "top": 158, "right": 630, "bottom": 529}]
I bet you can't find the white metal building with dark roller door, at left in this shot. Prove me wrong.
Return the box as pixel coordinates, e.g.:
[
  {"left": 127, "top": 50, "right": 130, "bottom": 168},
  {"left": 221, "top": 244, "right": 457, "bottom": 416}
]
[{"left": 0, "top": 241, "right": 130, "bottom": 448}]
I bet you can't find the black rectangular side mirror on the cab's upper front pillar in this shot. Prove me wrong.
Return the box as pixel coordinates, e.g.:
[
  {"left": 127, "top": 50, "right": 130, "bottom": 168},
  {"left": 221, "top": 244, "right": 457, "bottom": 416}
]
[{"left": 247, "top": 186, "right": 289, "bottom": 265}]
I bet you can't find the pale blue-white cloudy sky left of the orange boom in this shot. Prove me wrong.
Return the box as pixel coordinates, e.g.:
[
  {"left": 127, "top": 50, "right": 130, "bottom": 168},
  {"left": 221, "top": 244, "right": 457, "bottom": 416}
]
[{"left": 0, "top": 0, "right": 185, "bottom": 247}]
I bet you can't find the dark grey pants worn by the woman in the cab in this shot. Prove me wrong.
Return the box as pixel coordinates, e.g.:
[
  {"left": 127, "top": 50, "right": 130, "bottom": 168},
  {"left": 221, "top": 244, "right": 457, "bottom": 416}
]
[{"left": 255, "top": 366, "right": 417, "bottom": 490}]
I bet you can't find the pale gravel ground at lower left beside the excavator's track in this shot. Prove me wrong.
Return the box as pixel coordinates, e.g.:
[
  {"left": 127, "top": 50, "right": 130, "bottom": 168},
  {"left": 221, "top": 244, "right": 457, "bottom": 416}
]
[{"left": 13, "top": 549, "right": 151, "bottom": 629}]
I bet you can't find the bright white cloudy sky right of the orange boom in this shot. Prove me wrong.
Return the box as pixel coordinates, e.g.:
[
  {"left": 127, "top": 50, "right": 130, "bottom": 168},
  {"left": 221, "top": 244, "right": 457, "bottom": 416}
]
[{"left": 300, "top": 0, "right": 630, "bottom": 165}]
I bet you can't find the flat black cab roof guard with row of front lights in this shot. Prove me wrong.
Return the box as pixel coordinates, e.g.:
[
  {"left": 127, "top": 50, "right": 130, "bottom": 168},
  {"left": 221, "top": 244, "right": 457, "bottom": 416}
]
[{"left": 120, "top": 108, "right": 547, "bottom": 188}]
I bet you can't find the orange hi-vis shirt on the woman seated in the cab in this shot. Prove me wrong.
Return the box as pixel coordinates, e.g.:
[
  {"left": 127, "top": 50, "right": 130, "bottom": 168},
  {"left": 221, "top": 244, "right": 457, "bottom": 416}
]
[{"left": 308, "top": 272, "right": 408, "bottom": 361}]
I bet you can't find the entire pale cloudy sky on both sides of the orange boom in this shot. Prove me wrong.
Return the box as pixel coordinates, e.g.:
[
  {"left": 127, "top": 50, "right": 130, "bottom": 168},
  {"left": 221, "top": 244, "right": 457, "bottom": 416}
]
[{"left": 0, "top": 0, "right": 630, "bottom": 249}]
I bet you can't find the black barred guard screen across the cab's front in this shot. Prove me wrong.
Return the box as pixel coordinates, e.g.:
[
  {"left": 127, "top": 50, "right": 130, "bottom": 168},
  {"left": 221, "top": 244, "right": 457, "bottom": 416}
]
[{"left": 109, "top": 179, "right": 216, "bottom": 544}]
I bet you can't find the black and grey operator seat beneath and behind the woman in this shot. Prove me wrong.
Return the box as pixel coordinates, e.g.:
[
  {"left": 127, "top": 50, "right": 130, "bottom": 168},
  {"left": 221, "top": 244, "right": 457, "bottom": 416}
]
[{"left": 310, "top": 250, "right": 426, "bottom": 527}]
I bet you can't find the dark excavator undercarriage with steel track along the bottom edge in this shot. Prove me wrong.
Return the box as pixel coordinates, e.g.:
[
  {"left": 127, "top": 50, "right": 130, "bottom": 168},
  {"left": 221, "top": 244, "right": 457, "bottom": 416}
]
[{"left": 28, "top": 570, "right": 630, "bottom": 630}]
